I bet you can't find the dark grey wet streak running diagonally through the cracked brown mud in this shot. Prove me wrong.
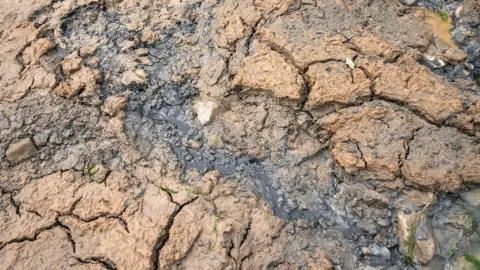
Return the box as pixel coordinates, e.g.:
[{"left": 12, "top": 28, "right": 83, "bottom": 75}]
[{"left": 50, "top": 3, "right": 480, "bottom": 267}]
